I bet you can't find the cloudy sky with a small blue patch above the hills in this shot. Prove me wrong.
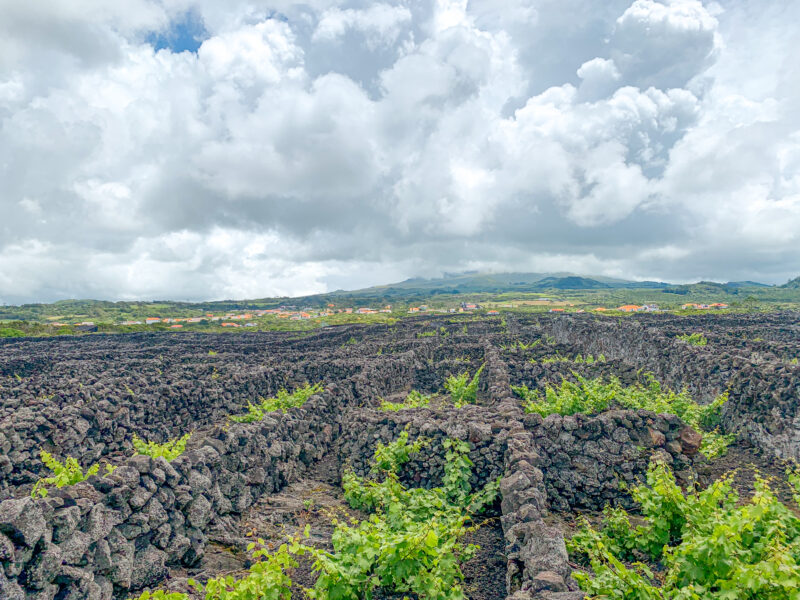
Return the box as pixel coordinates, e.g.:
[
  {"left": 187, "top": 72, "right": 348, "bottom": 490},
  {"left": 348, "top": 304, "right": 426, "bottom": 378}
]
[{"left": 0, "top": 0, "right": 800, "bottom": 304}]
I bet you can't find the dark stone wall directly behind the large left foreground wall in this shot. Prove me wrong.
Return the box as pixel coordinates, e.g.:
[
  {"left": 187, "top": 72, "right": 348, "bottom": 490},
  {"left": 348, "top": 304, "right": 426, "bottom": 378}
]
[{"left": 0, "top": 346, "right": 424, "bottom": 498}]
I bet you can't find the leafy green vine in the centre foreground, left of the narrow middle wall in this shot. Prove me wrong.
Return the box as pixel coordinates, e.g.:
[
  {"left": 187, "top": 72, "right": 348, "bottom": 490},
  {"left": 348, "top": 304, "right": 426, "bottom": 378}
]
[{"left": 296, "top": 432, "right": 499, "bottom": 600}]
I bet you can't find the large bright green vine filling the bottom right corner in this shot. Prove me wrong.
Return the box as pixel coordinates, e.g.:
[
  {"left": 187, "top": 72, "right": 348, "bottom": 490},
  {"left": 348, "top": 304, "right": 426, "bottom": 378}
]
[{"left": 567, "top": 464, "right": 800, "bottom": 600}]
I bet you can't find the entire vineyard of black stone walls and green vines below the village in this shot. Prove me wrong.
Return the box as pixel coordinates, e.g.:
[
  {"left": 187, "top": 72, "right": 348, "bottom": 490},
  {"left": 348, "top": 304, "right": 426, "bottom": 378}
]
[{"left": 0, "top": 313, "right": 800, "bottom": 600}]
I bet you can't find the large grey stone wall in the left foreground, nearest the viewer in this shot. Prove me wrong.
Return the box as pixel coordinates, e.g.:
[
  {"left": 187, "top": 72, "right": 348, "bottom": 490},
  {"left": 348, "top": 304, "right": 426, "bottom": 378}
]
[{"left": 0, "top": 386, "right": 355, "bottom": 600}]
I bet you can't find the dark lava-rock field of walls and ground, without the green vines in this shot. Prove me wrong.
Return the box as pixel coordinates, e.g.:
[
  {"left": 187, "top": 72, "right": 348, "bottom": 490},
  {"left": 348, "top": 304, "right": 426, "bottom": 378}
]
[{"left": 0, "top": 313, "right": 800, "bottom": 600}]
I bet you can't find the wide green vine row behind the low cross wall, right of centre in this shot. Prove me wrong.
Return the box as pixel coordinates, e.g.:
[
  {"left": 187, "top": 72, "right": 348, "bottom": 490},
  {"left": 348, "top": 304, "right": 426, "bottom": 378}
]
[{"left": 511, "top": 372, "right": 734, "bottom": 458}]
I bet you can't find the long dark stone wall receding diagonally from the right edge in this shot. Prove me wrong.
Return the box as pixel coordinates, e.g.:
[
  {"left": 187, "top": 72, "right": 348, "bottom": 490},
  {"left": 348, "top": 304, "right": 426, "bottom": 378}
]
[{"left": 518, "top": 315, "right": 800, "bottom": 460}]
